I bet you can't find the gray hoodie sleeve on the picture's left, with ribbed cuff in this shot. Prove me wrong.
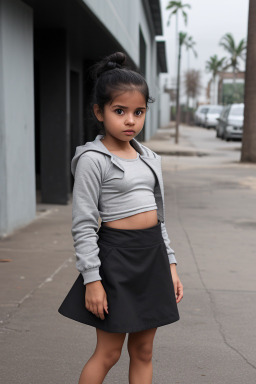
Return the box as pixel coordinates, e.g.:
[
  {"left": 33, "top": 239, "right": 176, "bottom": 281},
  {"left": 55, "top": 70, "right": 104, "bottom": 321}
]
[{"left": 71, "top": 153, "right": 101, "bottom": 284}]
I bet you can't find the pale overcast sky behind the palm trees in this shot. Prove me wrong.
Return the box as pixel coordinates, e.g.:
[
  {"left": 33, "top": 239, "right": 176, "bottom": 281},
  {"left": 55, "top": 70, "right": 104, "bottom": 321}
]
[{"left": 161, "top": 0, "right": 249, "bottom": 98}]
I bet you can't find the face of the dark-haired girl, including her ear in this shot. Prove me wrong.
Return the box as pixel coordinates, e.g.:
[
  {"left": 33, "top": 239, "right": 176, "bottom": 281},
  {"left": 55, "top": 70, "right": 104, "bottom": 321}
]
[{"left": 94, "top": 90, "right": 147, "bottom": 141}]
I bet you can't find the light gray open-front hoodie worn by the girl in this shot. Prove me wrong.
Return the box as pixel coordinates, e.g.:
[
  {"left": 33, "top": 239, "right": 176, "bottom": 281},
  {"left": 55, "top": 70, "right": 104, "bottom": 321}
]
[{"left": 71, "top": 135, "right": 177, "bottom": 284}]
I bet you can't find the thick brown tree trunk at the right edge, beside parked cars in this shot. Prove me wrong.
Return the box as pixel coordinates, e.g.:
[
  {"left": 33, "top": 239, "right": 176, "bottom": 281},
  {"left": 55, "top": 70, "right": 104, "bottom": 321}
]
[{"left": 241, "top": 0, "right": 256, "bottom": 163}]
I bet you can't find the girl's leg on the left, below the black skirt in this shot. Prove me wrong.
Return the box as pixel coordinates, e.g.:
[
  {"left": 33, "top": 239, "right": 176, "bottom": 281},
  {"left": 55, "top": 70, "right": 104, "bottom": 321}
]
[{"left": 79, "top": 328, "right": 126, "bottom": 384}]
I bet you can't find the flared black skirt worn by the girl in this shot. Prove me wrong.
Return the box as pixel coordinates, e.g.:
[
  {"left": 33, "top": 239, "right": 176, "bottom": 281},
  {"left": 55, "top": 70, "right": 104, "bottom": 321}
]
[{"left": 58, "top": 221, "right": 179, "bottom": 333}]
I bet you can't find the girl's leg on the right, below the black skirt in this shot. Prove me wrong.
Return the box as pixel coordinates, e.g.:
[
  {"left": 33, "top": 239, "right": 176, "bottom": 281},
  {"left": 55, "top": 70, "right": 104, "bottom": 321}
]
[{"left": 127, "top": 328, "right": 157, "bottom": 384}]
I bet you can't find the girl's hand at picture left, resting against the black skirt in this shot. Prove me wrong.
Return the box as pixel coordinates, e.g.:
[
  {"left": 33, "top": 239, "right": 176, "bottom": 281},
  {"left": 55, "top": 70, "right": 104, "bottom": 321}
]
[{"left": 85, "top": 280, "right": 108, "bottom": 320}]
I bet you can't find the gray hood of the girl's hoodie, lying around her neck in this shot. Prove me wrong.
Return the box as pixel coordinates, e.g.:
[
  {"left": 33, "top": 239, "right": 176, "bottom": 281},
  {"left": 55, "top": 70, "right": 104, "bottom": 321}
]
[{"left": 71, "top": 135, "right": 159, "bottom": 176}]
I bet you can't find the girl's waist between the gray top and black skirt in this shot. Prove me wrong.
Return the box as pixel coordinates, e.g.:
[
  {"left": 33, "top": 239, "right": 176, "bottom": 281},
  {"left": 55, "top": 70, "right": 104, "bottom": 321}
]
[{"left": 102, "top": 209, "right": 158, "bottom": 229}]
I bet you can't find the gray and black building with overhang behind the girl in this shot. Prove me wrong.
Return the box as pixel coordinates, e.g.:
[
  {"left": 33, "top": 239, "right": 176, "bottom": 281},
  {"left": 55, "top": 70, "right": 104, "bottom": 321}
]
[{"left": 0, "top": 0, "right": 167, "bottom": 236}]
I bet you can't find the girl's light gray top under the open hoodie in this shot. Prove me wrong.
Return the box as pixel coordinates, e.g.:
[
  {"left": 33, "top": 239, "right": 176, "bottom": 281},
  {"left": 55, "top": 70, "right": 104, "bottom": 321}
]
[{"left": 98, "top": 152, "right": 157, "bottom": 221}]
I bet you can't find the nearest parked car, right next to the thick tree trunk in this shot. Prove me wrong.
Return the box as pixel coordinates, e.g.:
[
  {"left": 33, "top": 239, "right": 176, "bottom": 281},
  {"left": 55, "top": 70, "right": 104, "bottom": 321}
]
[{"left": 216, "top": 103, "right": 244, "bottom": 141}]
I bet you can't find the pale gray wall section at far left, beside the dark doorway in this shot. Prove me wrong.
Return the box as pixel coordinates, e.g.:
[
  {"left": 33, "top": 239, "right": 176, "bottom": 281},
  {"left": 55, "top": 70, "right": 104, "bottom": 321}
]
[{"left": 0, "top": 0, "right": 35, "bottom": 236}]
